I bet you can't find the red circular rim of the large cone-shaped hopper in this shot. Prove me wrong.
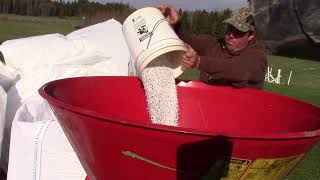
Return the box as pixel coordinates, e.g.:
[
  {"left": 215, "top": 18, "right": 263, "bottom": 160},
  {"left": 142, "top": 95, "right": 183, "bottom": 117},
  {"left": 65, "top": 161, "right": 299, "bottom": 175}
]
[{"left": 38, "top": 76, "right": 320, "bottom": 140}]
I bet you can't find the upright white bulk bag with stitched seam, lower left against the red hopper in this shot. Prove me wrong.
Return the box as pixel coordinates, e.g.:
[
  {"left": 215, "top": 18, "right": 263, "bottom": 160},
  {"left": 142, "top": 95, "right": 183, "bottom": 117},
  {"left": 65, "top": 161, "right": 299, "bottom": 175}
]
[{"left": 7, "top": 95, "right": 86, "bottom": 180}]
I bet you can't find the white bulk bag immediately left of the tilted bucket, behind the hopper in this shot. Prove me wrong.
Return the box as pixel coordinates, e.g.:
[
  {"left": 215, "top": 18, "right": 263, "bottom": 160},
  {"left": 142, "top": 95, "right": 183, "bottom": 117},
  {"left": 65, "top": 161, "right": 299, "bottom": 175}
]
[{"left": 66, "top": 19, "right": 130, "bottom": 76}]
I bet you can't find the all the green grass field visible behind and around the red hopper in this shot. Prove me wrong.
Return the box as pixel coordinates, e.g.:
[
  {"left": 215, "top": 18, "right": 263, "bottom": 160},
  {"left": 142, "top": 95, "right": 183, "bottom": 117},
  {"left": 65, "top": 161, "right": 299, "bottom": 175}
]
[{"left": 0, "top": 14, "right": 320, "bottom": 180}]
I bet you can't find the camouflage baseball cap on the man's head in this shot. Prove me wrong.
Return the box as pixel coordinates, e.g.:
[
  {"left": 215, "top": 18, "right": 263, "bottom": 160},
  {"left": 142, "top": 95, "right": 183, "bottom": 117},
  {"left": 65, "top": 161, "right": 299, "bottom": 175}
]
[{"left": 223, "top": 8, "right": 254, "bottom": 32}]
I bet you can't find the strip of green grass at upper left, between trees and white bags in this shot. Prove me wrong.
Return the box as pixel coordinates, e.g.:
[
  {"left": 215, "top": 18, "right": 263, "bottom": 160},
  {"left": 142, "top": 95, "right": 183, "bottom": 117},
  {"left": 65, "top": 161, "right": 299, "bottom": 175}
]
[{"left": 0, "top": 14, "right": 81, "bottom": 43}]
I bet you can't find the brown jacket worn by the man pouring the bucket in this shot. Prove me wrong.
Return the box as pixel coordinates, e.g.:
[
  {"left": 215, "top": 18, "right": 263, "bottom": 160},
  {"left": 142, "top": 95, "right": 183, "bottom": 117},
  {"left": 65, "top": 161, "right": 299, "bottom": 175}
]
[{"left": 177, "top": 29, "right": 267, "bottom": 89}]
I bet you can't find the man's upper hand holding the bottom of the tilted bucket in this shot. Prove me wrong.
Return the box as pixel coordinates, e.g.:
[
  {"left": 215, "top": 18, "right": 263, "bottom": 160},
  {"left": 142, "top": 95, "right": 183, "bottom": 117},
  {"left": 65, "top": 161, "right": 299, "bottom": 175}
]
[{"left": 154, "top": 4, "right": 181, "bottom": 26}]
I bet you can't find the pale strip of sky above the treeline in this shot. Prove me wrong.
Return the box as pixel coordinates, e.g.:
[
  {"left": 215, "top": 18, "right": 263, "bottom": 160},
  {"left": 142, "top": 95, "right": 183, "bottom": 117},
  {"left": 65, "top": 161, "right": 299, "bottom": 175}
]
[{"left": 89, "top": 0, "right": 247, "bottom": 11}]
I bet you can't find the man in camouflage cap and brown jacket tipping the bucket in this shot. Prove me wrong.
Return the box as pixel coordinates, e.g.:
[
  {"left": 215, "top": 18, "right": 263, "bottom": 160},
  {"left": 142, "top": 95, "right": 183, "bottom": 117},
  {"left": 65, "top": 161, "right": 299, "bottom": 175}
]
[{"left": 156, "top": 5, "right": 267, "bottom": 89}]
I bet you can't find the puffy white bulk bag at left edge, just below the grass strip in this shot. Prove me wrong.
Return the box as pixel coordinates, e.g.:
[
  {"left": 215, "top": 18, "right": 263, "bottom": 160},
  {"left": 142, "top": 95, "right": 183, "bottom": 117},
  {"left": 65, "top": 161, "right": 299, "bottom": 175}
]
[{"left": 0, "top": 34, "right": 81, "bottom": 69}]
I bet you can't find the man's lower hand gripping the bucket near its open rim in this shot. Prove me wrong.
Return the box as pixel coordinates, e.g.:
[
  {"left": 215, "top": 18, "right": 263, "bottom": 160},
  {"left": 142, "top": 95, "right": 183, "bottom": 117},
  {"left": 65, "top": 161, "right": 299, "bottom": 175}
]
[{"left": 181, "top": 43, "right": 200, "bottom": 69}]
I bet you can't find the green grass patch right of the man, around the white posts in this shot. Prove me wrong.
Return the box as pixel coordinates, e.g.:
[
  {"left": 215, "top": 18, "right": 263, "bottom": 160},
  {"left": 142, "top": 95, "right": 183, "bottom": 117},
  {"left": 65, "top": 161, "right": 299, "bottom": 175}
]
[{"left": 264, "top": 56, "right": 320, "bottom": 105}]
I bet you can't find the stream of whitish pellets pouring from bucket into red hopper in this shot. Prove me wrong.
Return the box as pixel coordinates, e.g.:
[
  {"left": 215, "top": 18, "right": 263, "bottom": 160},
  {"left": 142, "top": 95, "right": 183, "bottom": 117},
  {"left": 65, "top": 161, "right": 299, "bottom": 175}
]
[{"left": 141, "top": 55, "right": 179, "bottom": 126}]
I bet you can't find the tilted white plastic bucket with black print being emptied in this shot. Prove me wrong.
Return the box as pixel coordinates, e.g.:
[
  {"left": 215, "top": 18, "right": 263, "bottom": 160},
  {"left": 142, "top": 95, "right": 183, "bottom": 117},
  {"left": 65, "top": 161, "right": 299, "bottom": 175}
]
[{"left": 122, "top": 7, "right": 187, "bottom": 77}]
